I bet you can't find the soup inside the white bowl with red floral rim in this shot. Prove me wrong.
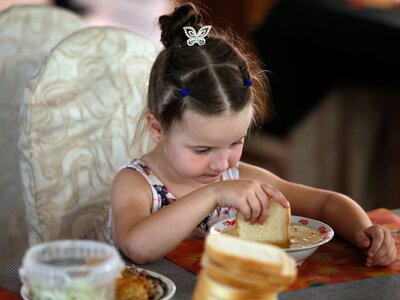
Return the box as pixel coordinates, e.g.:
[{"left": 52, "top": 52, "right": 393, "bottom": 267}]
[{"left": 221, "top": 223, "right": 322, "bottom": 248}]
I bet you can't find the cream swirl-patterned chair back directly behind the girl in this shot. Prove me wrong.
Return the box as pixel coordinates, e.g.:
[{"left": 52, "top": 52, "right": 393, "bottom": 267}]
[{"left": 18, "top": 27, "right": 160, "bottom": 244}]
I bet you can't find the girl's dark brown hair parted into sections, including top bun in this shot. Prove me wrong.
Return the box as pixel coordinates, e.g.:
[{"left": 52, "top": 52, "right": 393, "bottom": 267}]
[{"left": 138, "top": 3, "right": 268, "bottom": 135}]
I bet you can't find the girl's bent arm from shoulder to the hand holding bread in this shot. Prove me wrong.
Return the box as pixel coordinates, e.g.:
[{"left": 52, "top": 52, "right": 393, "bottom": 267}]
[{"left": 112, "top": 169, "right": 289, "bottom": 264}]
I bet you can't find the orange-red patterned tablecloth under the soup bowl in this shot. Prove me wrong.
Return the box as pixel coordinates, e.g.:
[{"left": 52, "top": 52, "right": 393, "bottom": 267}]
[{"left": 167, "top": 208, "right": 400, "bottom": 290}]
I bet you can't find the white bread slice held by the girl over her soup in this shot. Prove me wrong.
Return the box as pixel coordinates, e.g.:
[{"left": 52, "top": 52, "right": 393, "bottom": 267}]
[{"left": 236, "top": 200, "right": 291, "bottom": 248}]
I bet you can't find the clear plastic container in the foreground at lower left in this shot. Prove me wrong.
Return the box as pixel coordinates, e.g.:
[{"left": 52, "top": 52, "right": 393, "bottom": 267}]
[{"left": 20, "top": 240, "right": 124, "bottom": 300}]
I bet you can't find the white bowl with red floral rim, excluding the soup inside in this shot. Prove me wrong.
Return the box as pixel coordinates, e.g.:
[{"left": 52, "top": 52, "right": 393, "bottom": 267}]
[{"left": 210, "top": 216, "right": 334, "bottom": 265}]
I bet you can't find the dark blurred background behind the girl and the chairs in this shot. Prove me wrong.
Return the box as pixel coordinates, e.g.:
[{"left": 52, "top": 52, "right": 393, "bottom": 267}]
[{"left": 0, "top": 0, "right": 400, "bottom": 263}]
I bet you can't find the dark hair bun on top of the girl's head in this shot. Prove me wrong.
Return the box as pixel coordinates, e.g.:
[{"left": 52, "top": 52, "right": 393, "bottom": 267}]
[{"left": 158, "top": 3, "right": 202, "bottom": 48}]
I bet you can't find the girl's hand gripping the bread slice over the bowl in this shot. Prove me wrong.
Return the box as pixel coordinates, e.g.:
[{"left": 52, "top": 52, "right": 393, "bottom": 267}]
[{"left": 216, "top": 180, "right": 289, "bottom": 224}]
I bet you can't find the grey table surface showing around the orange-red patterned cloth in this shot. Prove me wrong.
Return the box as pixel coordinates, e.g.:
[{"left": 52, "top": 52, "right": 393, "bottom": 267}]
[{"left": 0, "top": 209, "right": 400, "bottom": 300}]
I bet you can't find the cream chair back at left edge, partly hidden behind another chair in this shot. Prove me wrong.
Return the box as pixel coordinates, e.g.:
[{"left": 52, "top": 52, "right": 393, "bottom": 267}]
[{"left": 0, "top": 5, "right": 86, "bottom": 257}]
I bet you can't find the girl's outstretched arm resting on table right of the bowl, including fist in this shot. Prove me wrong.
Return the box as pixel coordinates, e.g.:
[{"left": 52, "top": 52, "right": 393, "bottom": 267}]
[{"left": 240, "top": 163, "right": 396, "bottom": 266}]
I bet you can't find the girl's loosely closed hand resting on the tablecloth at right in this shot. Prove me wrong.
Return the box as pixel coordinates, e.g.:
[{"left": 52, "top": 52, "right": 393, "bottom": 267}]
[{"left": 356, "top": 225, "right": 397, "bottom": 267}]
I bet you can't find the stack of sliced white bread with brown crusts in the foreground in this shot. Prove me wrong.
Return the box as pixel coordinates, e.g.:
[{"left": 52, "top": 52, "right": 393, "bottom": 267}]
[{"left": 192, "top": 235, "right": 297, "bottom": 300}]
